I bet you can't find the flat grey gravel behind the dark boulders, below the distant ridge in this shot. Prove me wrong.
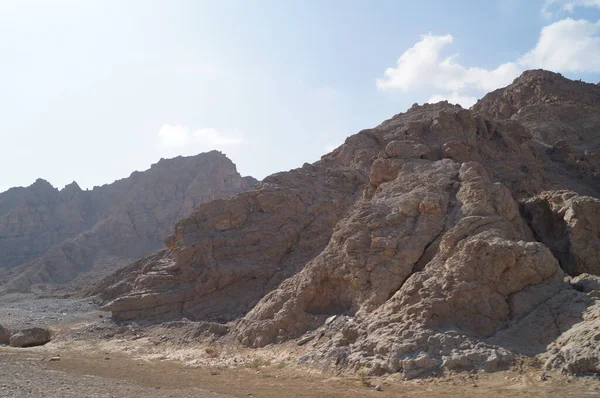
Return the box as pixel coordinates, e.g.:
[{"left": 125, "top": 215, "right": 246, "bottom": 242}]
[{"left": 0, "top": 293, "right": 102, "bottom": 330}]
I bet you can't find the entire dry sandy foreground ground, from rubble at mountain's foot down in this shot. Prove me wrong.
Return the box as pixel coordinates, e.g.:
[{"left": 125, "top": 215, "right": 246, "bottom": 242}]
[{"left": 0, "top": 299, "right": 600, "bottom": 398}]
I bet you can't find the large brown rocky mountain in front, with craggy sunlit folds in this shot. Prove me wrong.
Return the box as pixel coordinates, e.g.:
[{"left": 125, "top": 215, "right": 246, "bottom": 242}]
[{"left": 92, "top": 70, "right": 600, "bottom": 378}]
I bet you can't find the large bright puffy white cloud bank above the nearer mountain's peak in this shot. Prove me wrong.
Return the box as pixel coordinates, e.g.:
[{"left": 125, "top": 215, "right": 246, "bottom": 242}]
[{"left": 376, "top": 17, "right": 600, "bottom": 107}]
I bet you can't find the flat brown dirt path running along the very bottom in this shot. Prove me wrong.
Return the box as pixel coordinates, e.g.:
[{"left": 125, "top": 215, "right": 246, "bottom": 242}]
[{"left": 0, "top": 347, "right": 600, "bottom": 398}]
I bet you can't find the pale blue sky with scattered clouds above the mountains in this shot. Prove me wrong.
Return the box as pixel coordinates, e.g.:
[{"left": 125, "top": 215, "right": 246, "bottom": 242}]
[{"left": 0, "top": 0, "right": 600, "bottom": 192}]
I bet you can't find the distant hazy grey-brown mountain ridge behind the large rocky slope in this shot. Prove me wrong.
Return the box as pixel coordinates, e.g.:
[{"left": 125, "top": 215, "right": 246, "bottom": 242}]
[{"left": 0, "top": 151, "right": 256, "bottom": 291}]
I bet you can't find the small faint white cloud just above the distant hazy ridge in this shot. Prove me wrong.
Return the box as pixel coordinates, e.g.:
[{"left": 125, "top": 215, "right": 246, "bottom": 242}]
[{"left": 158, "top": 124, "right": 244, "bottom": 148}]
